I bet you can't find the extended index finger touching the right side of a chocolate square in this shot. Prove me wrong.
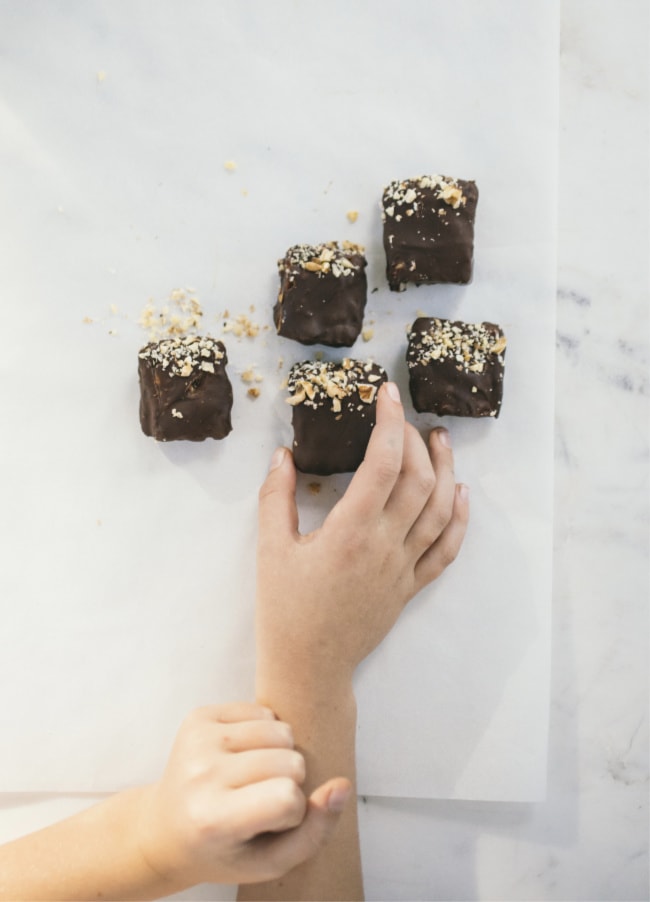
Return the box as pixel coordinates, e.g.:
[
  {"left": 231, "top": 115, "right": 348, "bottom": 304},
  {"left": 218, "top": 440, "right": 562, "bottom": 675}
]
[{"left": 340, "top": 382, "right": 405, "bottom": 519}]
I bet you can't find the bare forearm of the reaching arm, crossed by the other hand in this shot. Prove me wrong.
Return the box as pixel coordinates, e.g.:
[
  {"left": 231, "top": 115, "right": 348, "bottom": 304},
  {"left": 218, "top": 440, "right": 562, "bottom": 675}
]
[{"left": 238, "top": 659, "right": 363, "bottom": 902}]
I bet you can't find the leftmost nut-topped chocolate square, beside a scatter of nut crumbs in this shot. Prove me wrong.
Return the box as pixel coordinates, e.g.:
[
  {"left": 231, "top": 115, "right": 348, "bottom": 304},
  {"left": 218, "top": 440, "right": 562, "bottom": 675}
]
[{"left": 138, "top": 335, "right": 232, "bottom": 442}]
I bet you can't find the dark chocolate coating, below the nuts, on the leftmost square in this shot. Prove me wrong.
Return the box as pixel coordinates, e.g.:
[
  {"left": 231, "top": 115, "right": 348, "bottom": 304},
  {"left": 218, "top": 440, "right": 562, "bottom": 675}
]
[{"left": 138, "top": 341, "right": 233, "bottom": 442}]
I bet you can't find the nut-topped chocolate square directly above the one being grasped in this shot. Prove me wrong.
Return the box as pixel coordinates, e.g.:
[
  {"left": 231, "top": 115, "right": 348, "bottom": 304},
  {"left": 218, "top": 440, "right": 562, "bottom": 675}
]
[{"left": 273, "top": 241, "right": 368, "bottom": 347}]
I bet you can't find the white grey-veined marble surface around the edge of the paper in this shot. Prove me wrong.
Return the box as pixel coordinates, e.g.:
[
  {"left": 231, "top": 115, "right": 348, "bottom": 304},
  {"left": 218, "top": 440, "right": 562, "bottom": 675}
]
[{"left": 0, "top": 0, "right": 649, "bottom": 902}]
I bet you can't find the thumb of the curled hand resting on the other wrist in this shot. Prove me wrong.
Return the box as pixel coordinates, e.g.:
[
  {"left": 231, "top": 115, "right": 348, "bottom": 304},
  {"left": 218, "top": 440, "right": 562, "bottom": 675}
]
[{"left": 256, "top": 777, "right": 352, "bottom": 873}]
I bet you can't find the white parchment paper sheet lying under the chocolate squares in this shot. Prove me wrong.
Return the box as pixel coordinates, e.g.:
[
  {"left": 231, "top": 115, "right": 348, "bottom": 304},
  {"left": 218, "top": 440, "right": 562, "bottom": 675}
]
[{"left": 0, "top": 0, "right": 558, "bottom": 800}]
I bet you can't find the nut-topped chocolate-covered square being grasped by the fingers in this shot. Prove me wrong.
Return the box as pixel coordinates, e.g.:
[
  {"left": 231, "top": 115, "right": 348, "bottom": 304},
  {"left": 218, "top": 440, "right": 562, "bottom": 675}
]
[{"left": 287, "top": 358, "right": 386, "bottom": 476}]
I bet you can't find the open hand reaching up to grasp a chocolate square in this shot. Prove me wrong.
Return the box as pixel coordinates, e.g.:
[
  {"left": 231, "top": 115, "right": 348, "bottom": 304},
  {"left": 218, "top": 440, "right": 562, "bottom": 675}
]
[{"left": 257, "top": 384, "right": 468, "bottom": 687}]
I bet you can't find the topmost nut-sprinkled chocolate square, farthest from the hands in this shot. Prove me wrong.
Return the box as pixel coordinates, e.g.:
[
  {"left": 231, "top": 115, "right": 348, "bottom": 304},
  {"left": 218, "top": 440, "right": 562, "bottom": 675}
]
[{"left": 382, "top": 175, "right": 478, "bottom": 291}]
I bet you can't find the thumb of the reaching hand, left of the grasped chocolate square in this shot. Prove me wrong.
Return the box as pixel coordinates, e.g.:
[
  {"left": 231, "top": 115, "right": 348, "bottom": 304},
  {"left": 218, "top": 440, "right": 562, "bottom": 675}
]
[{"left": 258, "top": 448, "right": 298, "bottom": 542}]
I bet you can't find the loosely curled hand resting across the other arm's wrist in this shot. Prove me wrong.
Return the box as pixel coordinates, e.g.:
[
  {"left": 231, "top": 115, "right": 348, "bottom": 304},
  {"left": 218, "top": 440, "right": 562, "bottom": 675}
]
[{"left": 139, "top": 704, "right": 350, "bottom": 886}]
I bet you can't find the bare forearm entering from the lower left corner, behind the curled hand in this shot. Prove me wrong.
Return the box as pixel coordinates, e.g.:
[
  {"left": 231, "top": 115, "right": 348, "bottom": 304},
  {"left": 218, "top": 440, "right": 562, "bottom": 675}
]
[{"left": 0, "top": 787, "right": 183, "bottom": 902}]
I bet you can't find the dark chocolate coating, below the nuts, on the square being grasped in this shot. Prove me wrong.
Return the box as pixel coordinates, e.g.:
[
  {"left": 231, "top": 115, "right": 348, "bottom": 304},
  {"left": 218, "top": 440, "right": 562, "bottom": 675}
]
[{"left": 290, "top": 361, "right": 386, "bottom": 476}]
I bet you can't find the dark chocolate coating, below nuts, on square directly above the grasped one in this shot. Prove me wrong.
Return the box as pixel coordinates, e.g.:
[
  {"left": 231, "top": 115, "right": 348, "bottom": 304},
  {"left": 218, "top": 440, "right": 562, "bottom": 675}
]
[{"left": 273, "top": 245, "right": 368, "bottom": 347}]
